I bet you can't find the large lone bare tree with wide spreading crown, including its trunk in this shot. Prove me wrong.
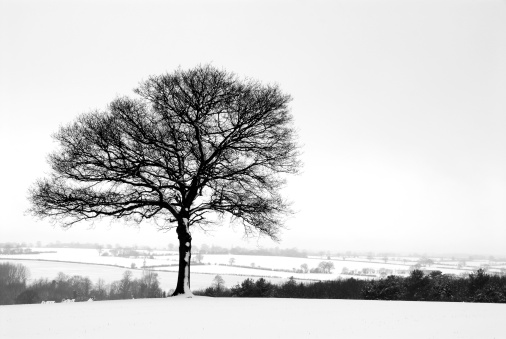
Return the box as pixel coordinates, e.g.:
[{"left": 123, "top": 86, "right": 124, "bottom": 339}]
[{"left": 30, "top": 66, "right": 299, "bottom": 295}]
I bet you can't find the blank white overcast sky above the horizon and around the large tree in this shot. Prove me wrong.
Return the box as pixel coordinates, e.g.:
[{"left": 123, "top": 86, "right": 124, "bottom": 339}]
[{"left": 0, "top": 0, "right": 506, "bottom": 255}]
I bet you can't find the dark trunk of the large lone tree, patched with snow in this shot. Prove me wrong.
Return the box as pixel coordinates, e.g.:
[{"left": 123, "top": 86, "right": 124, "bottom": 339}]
[{"left": 172, "top": 218, "right": 193, "bottom": 298}]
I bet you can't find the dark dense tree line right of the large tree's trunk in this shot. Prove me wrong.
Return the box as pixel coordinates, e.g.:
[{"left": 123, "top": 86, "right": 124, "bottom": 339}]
[{"left": 193, "top": 269, "right": 506, "bottom": 303}]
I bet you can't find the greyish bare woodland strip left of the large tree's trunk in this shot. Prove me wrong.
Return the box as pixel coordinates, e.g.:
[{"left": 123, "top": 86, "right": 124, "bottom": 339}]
[{"left": 0, "top": 263, "right": 165, "bottom": 305}]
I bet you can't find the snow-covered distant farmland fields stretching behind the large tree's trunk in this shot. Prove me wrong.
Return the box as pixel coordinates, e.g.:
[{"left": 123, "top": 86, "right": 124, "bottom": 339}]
[{"left": 0, "top": 248, "right": 506, "bottom": 290}]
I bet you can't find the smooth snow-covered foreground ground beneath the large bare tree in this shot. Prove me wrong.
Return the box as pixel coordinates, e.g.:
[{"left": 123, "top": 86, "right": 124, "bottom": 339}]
[{"left": 0, "top": 297, "right": 506, "bottom": 339}]
